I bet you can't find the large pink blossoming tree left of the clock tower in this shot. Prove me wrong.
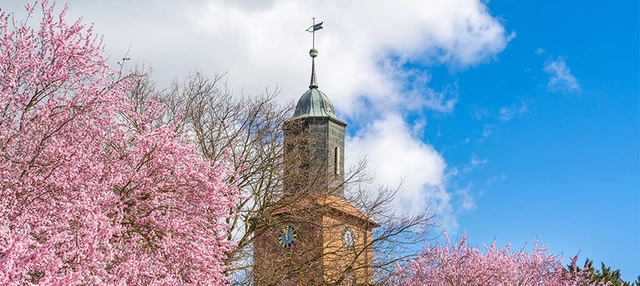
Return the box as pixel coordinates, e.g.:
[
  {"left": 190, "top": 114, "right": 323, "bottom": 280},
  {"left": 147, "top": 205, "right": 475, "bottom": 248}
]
[{"left": 0, "top": 1, "right": 238, "bottom": 285}]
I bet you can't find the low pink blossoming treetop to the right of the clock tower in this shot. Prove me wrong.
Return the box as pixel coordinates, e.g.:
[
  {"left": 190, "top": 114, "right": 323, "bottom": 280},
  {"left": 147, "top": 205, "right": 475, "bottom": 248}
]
[{"left": 395, "top": 234, "right": 608, "bottom": 286}]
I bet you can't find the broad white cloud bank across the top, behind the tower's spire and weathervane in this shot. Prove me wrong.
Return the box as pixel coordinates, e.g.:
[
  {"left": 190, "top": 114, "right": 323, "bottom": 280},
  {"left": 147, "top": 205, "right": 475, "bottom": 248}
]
[{"left": 3, "top": 0, "right": 514, "bottom": 114}]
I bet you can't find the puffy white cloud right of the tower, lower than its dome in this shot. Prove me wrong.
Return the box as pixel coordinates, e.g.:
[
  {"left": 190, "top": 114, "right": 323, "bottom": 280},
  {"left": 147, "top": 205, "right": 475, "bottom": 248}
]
[{"left": 345, "top": 114, "right": 454, "bottom": 225}]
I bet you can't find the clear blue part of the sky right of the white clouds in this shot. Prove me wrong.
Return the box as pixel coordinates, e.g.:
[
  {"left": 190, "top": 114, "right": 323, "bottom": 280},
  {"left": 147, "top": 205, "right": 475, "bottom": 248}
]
[{"left": 423, "top": 1, "right": 640, "bottom": 280}]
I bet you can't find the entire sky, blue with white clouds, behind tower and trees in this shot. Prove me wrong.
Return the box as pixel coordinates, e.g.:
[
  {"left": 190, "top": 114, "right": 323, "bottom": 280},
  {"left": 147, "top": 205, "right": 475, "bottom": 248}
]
[{"left": 0, "top": 0, "right": 640, "bottom": 280}]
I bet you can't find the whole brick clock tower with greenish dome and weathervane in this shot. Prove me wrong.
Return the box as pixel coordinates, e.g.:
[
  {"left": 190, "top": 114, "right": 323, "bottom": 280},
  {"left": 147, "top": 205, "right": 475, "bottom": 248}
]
[{"left": 253, "top": 20, "right": 377, "bottom": 285}]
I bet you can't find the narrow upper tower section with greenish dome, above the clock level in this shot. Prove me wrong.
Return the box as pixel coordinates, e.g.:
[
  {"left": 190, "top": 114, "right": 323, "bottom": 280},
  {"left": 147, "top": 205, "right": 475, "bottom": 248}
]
[{"left": 283, "top": 43, "right": 347, "bottom": 198}]
